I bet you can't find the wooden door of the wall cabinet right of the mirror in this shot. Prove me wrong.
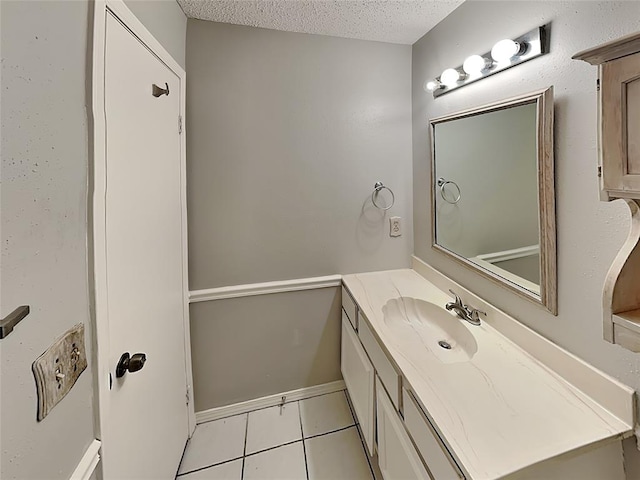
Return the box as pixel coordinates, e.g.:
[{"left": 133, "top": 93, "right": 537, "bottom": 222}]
[{"left": 600, "top": 53, "right": 640, "bottom": 194}]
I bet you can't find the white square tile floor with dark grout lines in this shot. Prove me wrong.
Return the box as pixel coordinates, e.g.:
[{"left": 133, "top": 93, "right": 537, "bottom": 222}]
[{"left": 176, "top": 391, "right": 374, "bottom": 480}]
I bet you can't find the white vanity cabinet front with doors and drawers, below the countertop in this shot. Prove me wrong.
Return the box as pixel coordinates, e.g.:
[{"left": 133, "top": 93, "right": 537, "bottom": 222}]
[{"left": 340, "top": 289, "right": 464, "bottom": 480}]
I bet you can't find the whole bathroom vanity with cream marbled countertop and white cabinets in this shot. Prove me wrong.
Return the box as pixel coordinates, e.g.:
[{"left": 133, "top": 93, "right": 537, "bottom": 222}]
[{"left": 341, "top": 258, "right": 634, "bottom": 480}]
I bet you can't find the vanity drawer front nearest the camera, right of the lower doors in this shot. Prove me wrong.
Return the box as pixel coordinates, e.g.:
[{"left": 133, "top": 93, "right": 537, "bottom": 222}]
[{"left": 402, "top": 388, "right": 465, "bottom": 480}]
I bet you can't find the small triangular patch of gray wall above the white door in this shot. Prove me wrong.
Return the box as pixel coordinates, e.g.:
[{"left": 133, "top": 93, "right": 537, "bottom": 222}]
[{"left": 124, "top": 0, "right": 187, "bottom": 68}]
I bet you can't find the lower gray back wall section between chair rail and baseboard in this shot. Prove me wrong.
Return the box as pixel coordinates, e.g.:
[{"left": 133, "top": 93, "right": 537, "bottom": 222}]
[{"left": 191, "top": 288, "right": 342, "bottom": 411}]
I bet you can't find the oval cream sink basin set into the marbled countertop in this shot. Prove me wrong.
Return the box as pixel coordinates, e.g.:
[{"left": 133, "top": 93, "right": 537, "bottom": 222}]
[{"left": 382, "top": 297, "right": 478, "bottom": 363}]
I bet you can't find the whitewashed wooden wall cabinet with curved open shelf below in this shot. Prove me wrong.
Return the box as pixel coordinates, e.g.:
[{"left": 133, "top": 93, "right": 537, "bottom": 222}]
[{"left": 573, "top": 32, "right": 640, "bottom": 352}]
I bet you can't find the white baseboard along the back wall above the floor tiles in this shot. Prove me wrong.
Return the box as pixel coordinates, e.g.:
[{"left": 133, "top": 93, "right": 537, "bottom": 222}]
[{"left": 196, "top": 380, "right": 346, "bottom": 424}]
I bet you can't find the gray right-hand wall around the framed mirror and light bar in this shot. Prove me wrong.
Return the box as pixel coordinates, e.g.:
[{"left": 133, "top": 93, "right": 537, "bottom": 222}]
[{"left": 412, "top": 1, "right": 640, "bottom": 472}]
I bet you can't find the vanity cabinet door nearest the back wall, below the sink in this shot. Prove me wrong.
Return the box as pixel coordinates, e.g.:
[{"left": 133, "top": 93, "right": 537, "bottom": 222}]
[{"left": 340, "top": 313, "right": 375, "bottom": 455}]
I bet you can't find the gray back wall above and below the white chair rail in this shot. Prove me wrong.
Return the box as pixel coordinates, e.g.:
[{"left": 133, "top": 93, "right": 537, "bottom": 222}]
[{"left": 187, "top": 19, "right": 412, "bottom": 407}]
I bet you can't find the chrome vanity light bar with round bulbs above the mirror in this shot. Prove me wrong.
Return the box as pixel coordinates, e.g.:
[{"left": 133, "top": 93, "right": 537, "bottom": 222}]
[{"left": 424, "top": 26, "right": 549, "bottom": 98}]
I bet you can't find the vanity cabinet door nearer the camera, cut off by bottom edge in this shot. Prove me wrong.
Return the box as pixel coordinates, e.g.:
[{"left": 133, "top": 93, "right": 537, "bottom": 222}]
[{"left": 376, "top": 382, "right": 429, "bottom": 480}]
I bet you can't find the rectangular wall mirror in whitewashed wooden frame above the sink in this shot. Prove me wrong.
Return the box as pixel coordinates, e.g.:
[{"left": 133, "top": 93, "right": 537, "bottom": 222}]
[{"left": 430, "top": 87, "right": 557, "bottom": 315}]
